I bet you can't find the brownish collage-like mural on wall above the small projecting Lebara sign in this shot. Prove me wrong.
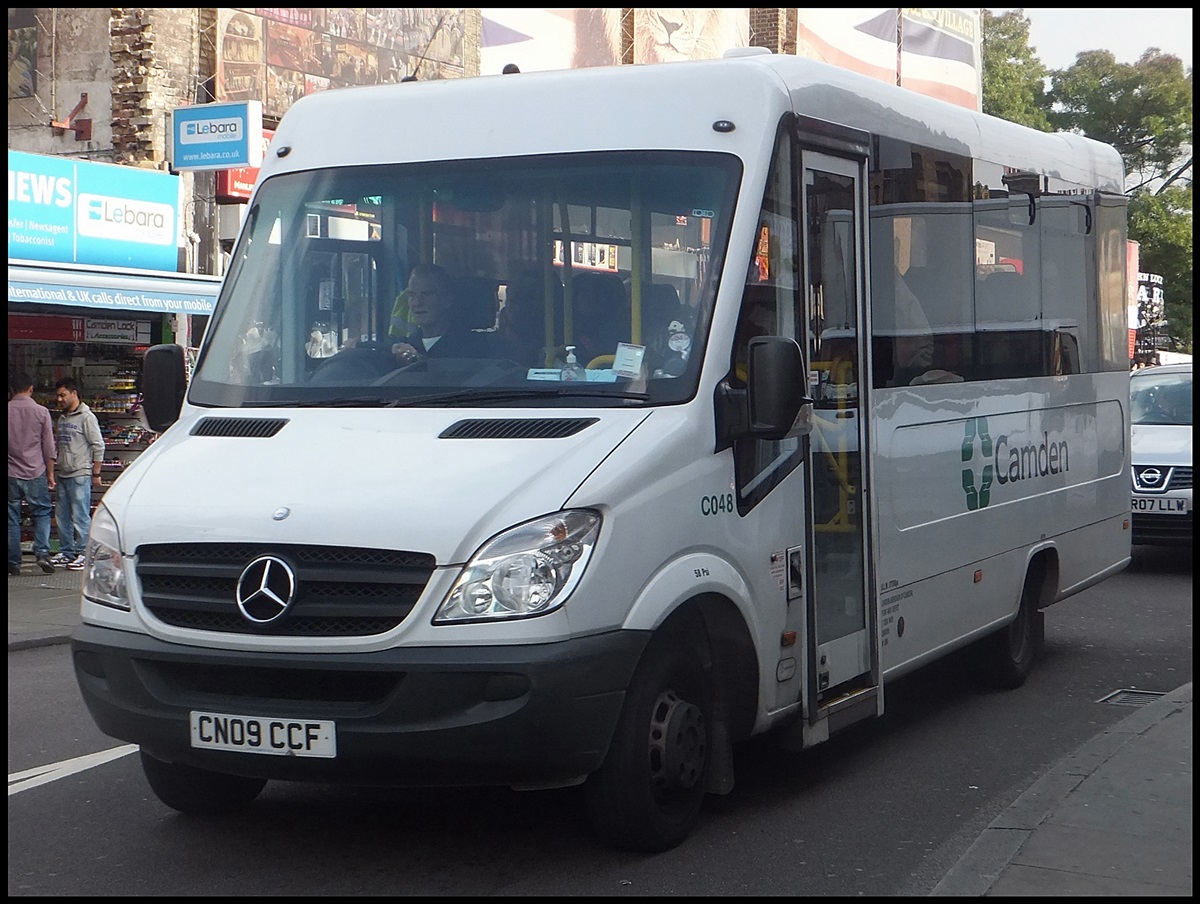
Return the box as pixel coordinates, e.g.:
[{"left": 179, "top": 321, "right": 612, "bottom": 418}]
[{"left": 216, "top": 8, "right": 464, "bottom": 118}]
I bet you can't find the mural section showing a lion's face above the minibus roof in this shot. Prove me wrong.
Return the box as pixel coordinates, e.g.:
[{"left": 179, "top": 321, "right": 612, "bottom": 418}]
[{"left": 480, "top": 8, "right": 750, "bottom": 76}]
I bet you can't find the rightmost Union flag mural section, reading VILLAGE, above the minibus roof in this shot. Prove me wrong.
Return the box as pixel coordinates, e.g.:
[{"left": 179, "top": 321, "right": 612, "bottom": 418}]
[{"left": 796, "top": 7, "right": 983, "bottom": 110}]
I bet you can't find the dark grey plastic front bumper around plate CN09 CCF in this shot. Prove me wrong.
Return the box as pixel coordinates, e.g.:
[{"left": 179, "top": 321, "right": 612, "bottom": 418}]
[{"left": 71, "top": 624, "right": 649, "bottom": 786}]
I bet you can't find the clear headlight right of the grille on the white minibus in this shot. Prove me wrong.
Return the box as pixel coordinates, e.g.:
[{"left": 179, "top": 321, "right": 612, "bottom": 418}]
[{"left": 433, "top": 510, "right": 600, "bottom": 624}]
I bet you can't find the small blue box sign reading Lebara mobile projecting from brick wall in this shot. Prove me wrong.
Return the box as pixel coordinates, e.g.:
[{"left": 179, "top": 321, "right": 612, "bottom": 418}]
[{"left": 170, "top": 101, "right": 263, "bottom": 170}]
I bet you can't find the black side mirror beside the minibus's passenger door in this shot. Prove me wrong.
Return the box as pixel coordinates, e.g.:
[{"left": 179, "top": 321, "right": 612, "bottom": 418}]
[{"left": 746, "top": 336, "right": 812, "bottom": 439}]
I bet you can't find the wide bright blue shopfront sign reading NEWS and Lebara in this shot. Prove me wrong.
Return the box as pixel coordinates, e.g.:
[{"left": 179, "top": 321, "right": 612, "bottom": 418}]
[{"left": 8, "top": 151, "right": 180, "bottom": 271}]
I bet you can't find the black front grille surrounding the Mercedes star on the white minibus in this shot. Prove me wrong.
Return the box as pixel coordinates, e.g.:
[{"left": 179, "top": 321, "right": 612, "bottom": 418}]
[{"left": 137, "top": 543, "right": 437, "bottom": 637}]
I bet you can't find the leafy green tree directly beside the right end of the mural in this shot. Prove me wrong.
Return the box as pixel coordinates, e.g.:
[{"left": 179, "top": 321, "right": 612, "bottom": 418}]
[{"left": 979, "top": 10, "right": 1050, "bottom": 132}]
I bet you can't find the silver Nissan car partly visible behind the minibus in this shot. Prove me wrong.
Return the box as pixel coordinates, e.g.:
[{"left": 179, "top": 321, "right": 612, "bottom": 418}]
[{"left": 1129, "top": 364, "right": 1192, "bottom": 546}]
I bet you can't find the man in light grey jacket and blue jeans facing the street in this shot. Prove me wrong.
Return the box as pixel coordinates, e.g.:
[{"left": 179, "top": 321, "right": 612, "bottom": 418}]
[{"left": 50, "top": 377, "right": 104, "bottom": 571}]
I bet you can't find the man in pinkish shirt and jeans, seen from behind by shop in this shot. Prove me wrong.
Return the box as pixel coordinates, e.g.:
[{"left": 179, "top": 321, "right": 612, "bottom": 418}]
[{"left": 8, "top": 373, "right": 55, "bottom": 576}]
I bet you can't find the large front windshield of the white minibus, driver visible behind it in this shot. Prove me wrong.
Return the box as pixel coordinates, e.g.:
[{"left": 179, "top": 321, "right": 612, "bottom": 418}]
[{"left": 188, "top": 152, "right": 740, "bottom": 407}]
